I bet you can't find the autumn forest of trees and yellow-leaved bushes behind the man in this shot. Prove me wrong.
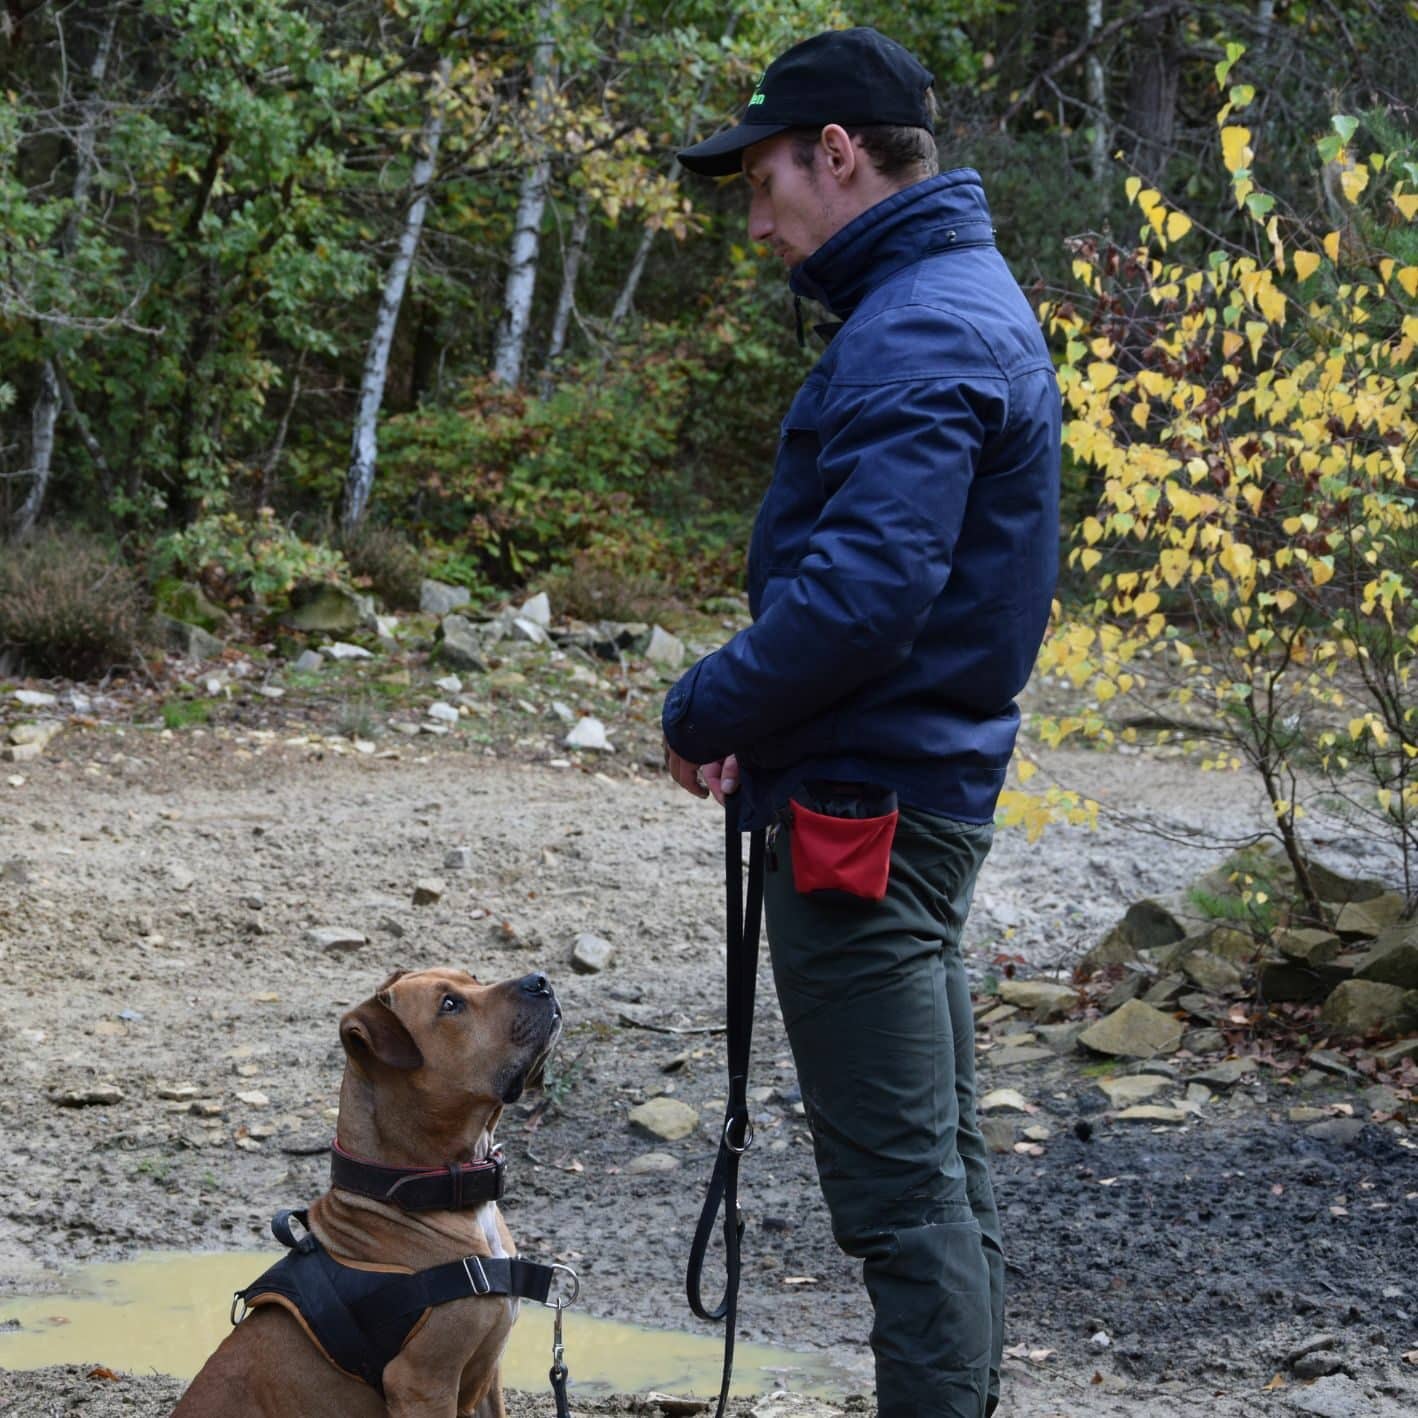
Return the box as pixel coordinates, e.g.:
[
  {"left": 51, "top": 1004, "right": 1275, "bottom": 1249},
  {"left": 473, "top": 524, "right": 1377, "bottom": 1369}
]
[{"left": 0, "top": 0, "right": 1418, "bottom": 903}]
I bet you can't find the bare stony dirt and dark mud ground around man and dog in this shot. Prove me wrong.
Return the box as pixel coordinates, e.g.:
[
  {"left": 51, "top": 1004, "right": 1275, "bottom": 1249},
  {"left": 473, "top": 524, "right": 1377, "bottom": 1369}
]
[{"left": 0, "top": 691, "right": 1418, "bottom": 1418}]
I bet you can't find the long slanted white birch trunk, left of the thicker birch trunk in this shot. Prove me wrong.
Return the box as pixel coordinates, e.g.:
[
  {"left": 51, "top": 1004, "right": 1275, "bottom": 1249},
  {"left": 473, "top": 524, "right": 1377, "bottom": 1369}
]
[{"left": 340, "top": 60, "right": 452, "bottom": 532}]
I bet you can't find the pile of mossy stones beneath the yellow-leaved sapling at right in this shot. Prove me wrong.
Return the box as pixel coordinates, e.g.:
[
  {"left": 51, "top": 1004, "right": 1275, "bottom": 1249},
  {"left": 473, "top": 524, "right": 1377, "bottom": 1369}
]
[{"left": 1066, "top": 848, "right": 1418, "bottom": 1062}]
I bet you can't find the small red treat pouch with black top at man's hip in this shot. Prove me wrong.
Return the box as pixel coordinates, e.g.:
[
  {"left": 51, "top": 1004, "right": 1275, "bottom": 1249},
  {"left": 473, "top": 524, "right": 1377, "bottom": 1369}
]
[{"left": 790, "top": 781, "right": 900, "bottom": 900}]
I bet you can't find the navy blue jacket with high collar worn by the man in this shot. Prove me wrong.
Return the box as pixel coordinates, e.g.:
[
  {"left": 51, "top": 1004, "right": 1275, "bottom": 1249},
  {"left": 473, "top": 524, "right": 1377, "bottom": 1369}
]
[{"left": 664, "top": 169, "right": 1061, "bottom": 828}]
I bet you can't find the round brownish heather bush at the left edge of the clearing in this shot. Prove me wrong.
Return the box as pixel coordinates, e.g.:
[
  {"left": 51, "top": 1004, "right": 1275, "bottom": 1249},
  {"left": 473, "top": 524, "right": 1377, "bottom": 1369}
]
[{"left": 0, "top": 532, "right": 143, "bottom": 678}]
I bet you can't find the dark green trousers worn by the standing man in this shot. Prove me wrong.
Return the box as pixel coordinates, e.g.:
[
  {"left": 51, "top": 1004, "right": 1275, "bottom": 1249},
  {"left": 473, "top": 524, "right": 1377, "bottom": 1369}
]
[{"left": 764, "top": 808, "right": 1004, "bottom": 1418}]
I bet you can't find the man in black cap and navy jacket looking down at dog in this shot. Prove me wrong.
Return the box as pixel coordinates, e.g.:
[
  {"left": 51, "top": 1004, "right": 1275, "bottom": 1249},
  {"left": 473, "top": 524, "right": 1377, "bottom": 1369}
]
[{"left": 664, "top": 28, "right": 1059, "bottom": 1418}]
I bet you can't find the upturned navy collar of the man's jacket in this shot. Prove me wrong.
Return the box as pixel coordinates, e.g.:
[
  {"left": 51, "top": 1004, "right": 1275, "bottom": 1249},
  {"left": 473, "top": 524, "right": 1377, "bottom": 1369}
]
[{"left": 788, "top": 167, "right": 994, "bottom": 319}]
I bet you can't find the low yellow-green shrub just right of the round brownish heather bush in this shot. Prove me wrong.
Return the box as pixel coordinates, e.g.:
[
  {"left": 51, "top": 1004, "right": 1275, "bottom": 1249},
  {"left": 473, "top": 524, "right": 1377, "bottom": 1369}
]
[{"left": 152, "top": 508, "right": 349, "bottom": 601}]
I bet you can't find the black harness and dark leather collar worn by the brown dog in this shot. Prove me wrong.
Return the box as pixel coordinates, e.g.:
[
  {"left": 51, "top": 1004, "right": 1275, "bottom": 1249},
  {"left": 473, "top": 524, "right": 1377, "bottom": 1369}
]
[{"left": 231, "top": 1143, "right": 580, "bottom": 1414}]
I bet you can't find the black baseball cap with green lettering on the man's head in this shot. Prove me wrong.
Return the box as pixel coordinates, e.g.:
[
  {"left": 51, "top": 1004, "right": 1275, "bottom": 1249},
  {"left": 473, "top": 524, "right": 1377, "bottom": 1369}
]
[{"left": 678, "top": 26, "right": 936, "bottom": 177}]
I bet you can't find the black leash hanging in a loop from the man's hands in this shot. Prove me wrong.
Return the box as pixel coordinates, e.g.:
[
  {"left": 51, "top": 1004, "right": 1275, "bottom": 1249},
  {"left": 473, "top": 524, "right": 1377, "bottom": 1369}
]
[{"left": 685, "top": 794, "right": 764, "bottom": 1418}]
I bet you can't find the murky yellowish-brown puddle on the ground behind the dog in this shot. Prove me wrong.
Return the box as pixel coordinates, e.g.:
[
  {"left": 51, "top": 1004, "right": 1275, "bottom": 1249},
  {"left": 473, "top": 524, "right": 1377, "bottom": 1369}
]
[{"left": 0, "top": 1251, "right": 871, "bottom": 1398}]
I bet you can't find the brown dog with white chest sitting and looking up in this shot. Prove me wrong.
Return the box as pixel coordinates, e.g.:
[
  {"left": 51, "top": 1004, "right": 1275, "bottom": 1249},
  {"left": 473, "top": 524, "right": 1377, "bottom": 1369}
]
[{"left": 173, "top": 970, "right": 562, "bottom": 1418}]
